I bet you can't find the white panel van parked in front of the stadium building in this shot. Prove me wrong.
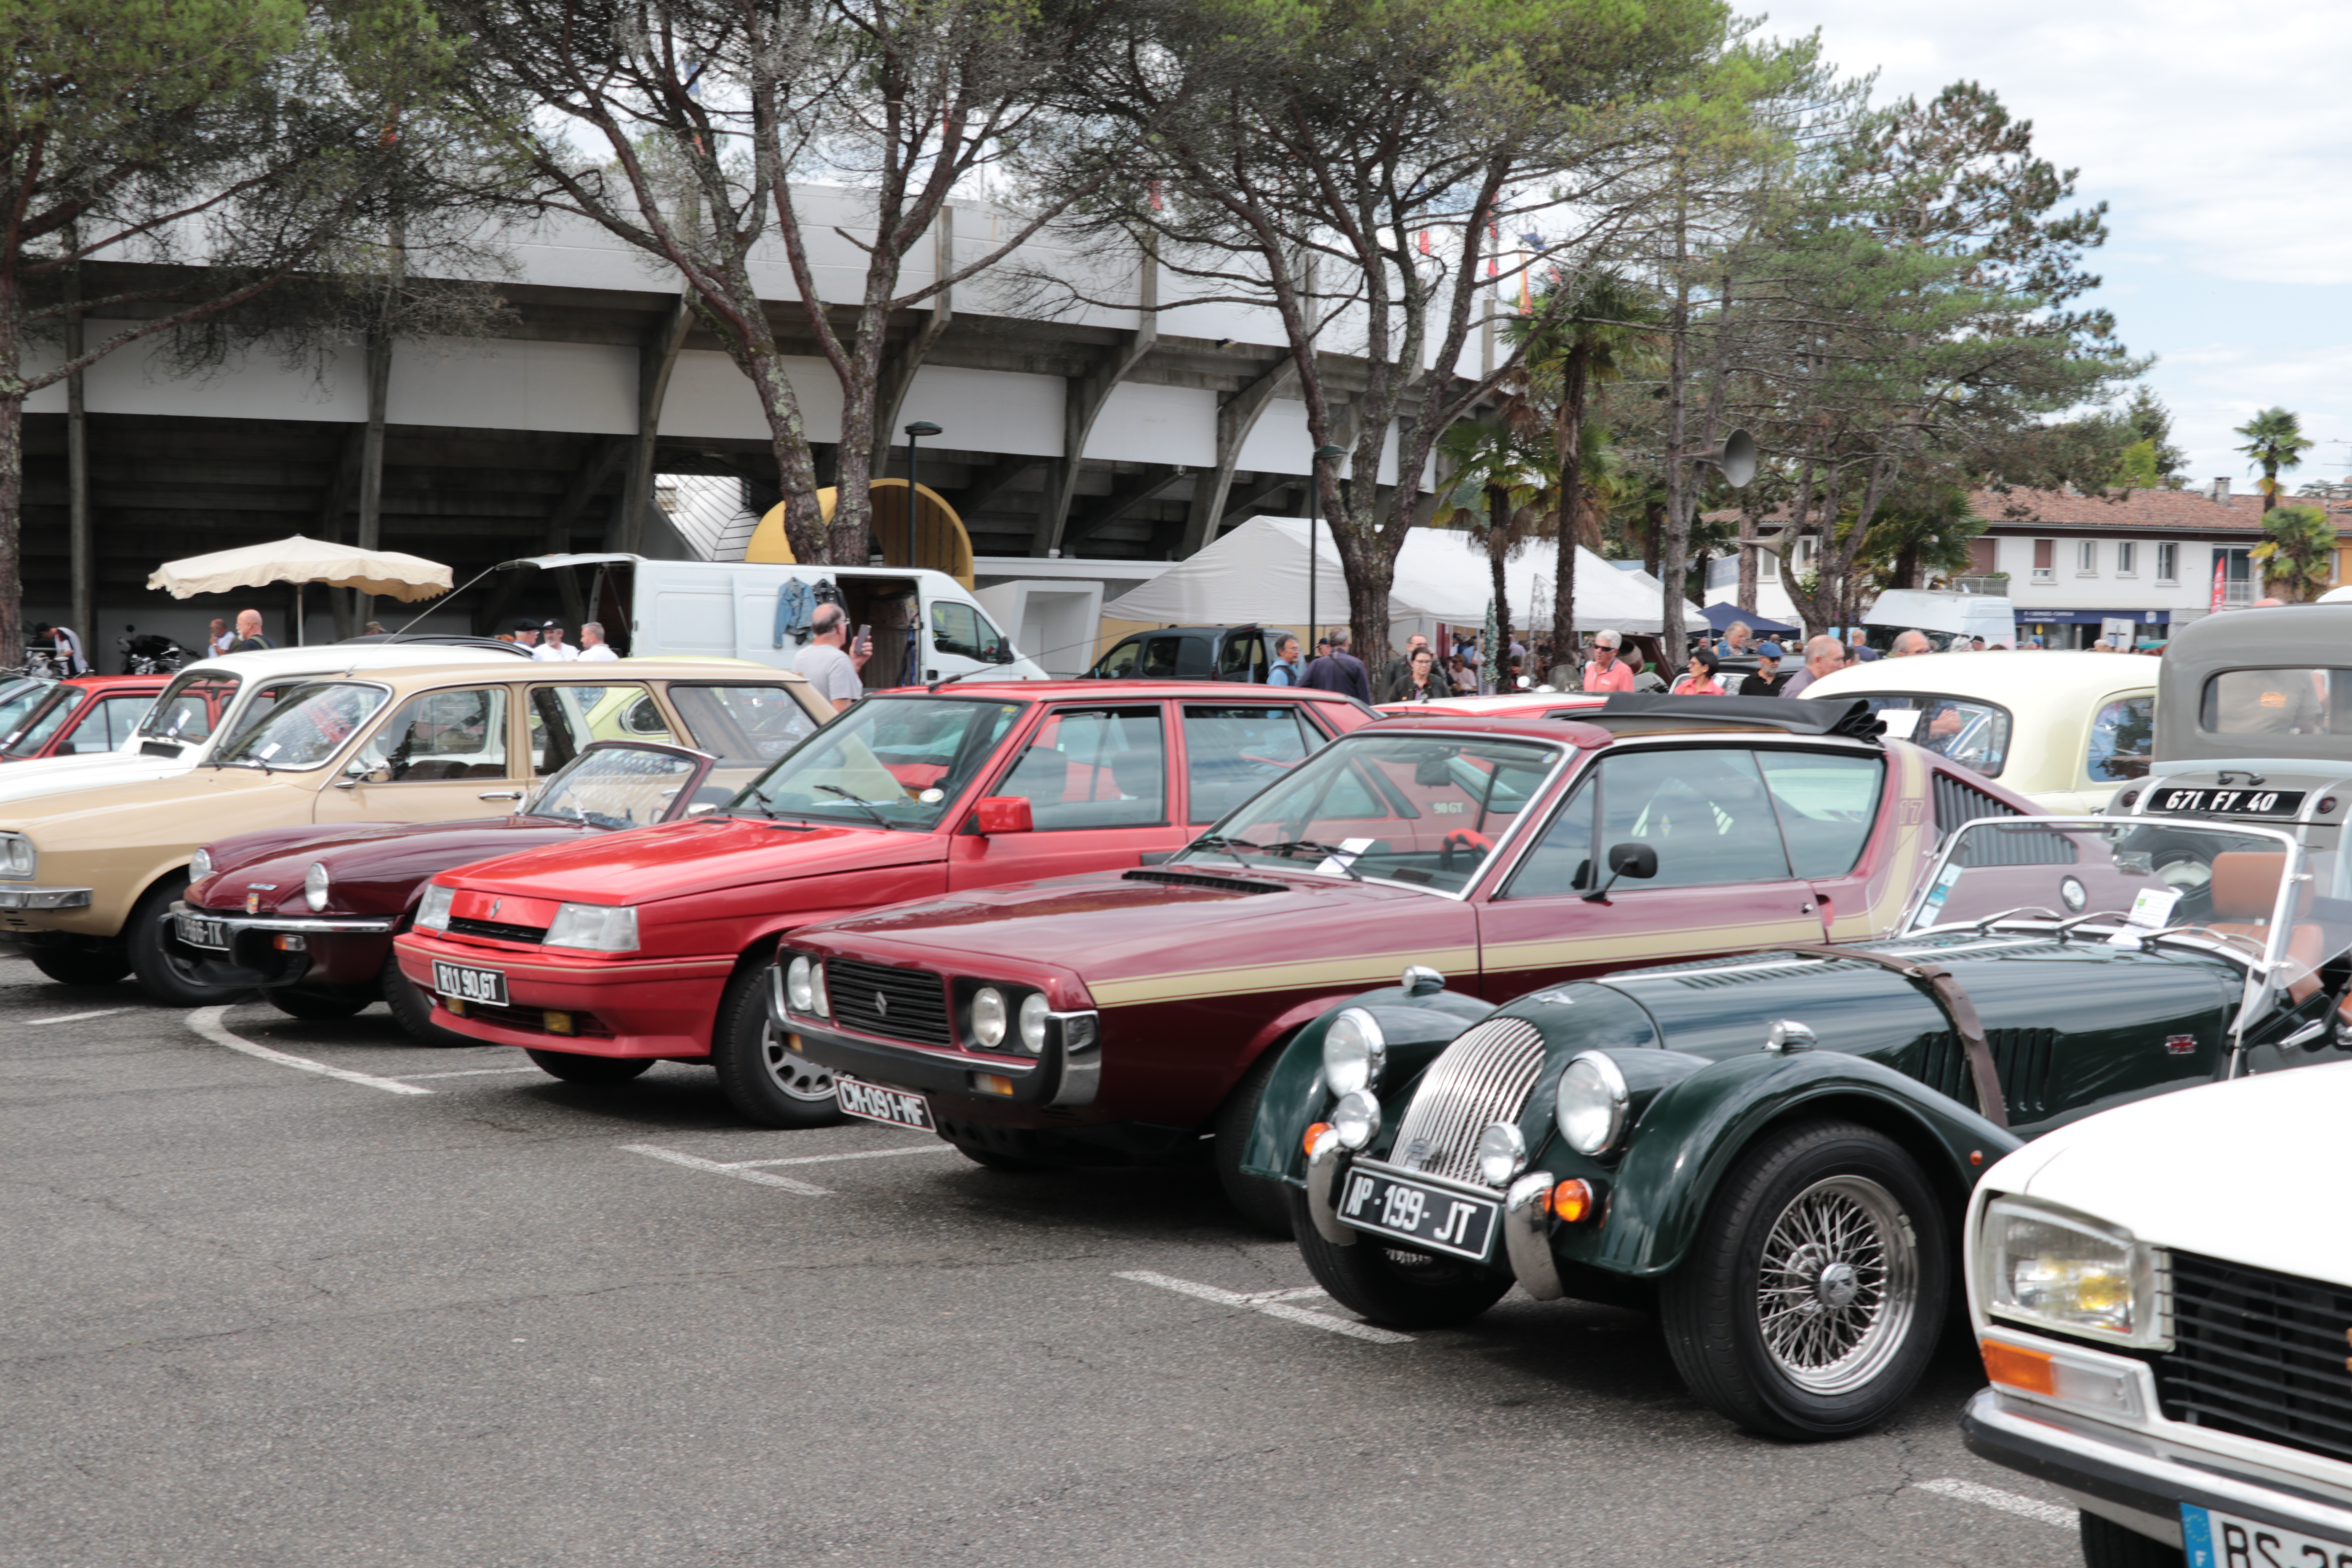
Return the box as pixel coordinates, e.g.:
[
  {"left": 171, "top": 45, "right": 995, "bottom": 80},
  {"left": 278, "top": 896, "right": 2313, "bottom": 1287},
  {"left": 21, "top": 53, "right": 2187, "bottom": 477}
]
[{"left": 501, "top": 555, "right": 1047, "bottom": 691}]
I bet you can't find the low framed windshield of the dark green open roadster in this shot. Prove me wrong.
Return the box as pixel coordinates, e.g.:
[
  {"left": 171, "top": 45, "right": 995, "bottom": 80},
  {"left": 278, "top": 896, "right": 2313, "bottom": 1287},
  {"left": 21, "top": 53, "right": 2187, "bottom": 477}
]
[{"left": 1910, "top": 816, "right": 2352, "bottom": 1002}]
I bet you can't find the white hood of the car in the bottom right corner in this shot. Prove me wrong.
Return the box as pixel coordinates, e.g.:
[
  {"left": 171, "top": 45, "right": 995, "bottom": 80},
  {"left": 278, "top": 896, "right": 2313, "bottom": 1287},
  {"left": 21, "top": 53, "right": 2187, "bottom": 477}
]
[{"left": 1985, "top": 1063, "right": 2352, "bottom": 1283}]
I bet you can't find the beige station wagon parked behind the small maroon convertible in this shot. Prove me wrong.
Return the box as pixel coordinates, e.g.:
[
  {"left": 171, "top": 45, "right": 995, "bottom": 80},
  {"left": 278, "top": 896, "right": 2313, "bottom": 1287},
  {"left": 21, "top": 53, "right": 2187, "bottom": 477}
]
[{"left": 0, "top": 658, "right": 833, "bottom": 1006}]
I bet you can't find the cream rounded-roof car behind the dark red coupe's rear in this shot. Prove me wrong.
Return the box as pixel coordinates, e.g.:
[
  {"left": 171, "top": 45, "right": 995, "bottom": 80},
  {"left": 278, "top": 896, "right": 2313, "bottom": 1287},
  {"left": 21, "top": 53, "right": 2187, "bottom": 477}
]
[{"left": 1804, "top": 649, "right": 2159, "bottom": 813}]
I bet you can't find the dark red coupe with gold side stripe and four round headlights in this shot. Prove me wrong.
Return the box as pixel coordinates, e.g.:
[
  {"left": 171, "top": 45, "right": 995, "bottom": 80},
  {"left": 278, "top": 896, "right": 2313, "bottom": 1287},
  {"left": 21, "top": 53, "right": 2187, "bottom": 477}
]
[{"left": 774, "top": 696, "right": 2037, "bottom": 1229}]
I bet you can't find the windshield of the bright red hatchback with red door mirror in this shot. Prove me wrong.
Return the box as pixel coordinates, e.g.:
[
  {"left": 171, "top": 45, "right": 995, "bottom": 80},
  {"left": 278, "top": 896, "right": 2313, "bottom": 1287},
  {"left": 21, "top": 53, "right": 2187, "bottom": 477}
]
[{"left": 729, "top": 696, "right": 1028, "bottom": 830}]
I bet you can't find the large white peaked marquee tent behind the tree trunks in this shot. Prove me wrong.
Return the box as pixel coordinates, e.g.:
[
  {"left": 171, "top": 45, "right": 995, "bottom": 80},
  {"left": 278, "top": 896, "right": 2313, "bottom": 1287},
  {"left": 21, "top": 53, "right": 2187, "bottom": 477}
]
[{"left": 1103, "top": 517, "right": 1705, "bottom": 646}]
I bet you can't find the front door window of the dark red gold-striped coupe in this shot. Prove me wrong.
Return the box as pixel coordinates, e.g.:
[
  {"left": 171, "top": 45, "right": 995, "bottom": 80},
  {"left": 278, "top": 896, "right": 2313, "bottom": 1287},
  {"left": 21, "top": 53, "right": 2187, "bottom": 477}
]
[{"left": 1597, "top": 748, "right": 1790, "bottom": 891}]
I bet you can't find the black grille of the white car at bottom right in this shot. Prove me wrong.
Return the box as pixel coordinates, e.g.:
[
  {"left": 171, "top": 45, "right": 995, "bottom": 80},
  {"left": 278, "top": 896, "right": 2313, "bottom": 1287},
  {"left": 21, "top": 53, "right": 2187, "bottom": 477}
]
[{"left": 2157, "top": 1253, "right": 2352, "bottom": 1460}]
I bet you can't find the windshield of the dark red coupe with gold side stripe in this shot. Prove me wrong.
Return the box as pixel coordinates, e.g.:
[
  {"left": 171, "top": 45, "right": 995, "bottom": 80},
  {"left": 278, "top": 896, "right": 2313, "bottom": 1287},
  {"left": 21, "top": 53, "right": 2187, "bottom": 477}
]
[{"left": 1178, "top": 724, "right": 1566, "bottom": 893}]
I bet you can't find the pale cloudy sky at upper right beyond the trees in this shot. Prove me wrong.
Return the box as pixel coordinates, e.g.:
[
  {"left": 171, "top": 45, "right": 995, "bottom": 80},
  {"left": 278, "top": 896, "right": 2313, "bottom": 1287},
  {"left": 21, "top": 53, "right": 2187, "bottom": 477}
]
[{"left": 1766, "top": 0, "right": 2352, "bottom": 489}]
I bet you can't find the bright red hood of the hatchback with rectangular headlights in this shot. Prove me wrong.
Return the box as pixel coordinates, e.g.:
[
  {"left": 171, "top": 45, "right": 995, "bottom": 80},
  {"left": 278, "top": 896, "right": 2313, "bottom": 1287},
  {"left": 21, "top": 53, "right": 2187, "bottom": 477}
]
[{"left": 433, "top": 816, "right": 948, "bottom": 905}]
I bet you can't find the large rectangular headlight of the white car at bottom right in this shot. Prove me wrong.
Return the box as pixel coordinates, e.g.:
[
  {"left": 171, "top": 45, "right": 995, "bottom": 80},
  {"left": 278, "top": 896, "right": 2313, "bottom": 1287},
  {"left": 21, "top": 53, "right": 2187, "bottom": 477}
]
[{"left": 1978, "top": 1196, "right": 2171, "bottom": 1347}]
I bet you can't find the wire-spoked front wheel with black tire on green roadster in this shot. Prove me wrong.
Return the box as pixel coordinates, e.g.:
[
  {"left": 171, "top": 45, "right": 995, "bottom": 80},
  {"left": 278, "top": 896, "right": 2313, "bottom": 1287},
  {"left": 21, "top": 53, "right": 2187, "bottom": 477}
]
[{"left": 1658, "top": 1122, "right": 1950, "bottom": 1441}]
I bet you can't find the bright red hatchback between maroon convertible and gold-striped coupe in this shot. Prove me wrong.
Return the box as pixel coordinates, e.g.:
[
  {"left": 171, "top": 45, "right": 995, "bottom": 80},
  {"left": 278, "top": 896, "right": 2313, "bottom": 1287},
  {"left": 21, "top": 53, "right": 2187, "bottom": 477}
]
[{"left": 395, "top": 682, "right": 1374, "bottom": 1126}]
